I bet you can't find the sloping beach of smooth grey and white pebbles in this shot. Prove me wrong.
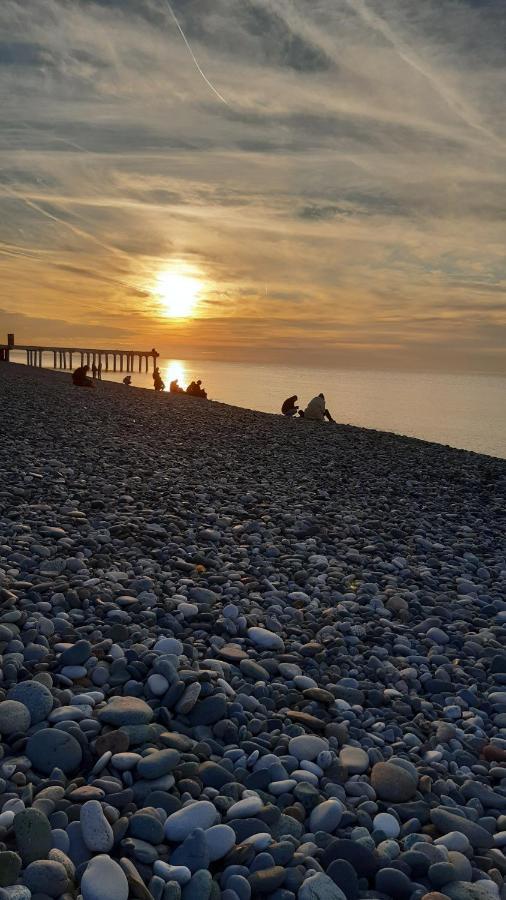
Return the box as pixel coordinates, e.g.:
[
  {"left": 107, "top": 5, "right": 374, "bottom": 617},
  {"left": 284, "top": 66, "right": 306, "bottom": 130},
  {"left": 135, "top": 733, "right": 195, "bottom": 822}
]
[{"left": 0, "top": 363, "right": 506, "bottom": 900}]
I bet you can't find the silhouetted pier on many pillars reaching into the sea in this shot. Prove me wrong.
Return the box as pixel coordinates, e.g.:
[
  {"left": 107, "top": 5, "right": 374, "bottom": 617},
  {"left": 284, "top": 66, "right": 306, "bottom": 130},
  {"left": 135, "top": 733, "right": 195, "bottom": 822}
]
[{"left": 0, "top": 334, "right": 160, "bottom": 372}]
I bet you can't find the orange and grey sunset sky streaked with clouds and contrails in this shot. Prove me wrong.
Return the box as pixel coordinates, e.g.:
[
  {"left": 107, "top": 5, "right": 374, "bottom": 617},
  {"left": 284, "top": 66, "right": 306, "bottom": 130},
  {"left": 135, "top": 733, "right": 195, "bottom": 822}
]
[{"left": 0, "top": 0, "right": 506, "bottom": 373}]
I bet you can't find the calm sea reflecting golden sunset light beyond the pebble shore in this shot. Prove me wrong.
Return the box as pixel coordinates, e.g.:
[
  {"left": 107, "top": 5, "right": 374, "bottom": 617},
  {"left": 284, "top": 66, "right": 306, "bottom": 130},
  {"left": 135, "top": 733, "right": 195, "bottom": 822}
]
[{"left": 7, "top": 354, "right": 506, "bottom": 457}]
